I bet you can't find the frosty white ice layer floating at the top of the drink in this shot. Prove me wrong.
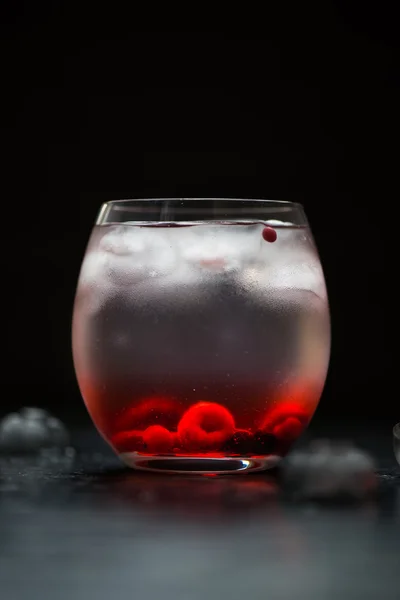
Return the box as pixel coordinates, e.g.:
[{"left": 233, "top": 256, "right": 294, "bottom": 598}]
[{"left": 79, "top": 220, "right": 326, "bottom": 313}]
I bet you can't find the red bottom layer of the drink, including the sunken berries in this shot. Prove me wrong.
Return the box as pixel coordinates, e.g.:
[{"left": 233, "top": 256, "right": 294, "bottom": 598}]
[{"left": 80, "top": 385, "right": 318, "bottom": 458}]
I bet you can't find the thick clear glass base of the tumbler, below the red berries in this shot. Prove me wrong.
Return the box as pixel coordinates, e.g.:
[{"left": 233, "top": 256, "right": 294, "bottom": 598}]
[{"left": 119, "top": 452, "right": 282, "bottom": 475}]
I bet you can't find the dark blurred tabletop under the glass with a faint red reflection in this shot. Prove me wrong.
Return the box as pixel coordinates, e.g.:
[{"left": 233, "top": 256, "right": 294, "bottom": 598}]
[{"left": 0, "top": 428, "right": 400, "bottom": 600}]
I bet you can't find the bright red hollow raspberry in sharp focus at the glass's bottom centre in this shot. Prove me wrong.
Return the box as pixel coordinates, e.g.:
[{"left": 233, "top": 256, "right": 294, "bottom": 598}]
[{"left": 178, "top": 402, "right": 235, "bottom": 450}]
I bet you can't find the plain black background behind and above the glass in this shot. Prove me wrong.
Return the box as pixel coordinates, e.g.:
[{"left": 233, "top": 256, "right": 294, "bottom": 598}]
[{"left": 0, "top": 1, "right": 400, "bottom": 425}]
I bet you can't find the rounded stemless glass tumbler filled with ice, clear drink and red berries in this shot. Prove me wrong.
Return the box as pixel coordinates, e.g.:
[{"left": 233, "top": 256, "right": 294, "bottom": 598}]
[{"left": 73, "top": 199, "right": 330, "bottom": 474}]
